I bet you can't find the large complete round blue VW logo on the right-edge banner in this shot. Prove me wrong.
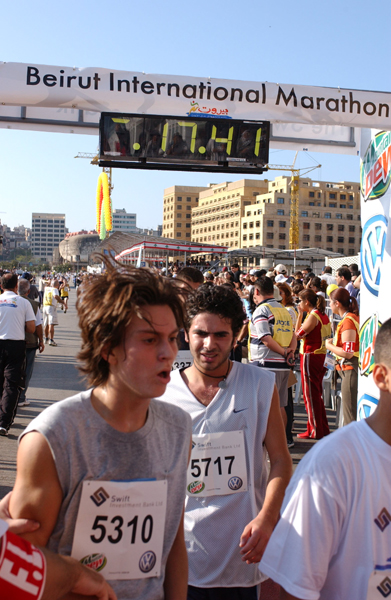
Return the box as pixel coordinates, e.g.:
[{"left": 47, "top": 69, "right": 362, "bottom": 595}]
[{"left": 361, "top": 215, "right": 388, "bottom": 296}]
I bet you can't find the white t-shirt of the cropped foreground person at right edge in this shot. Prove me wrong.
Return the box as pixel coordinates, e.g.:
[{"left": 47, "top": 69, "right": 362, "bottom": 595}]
[{"left": 259, "top": 421, "right": 391, "bottom": 600}]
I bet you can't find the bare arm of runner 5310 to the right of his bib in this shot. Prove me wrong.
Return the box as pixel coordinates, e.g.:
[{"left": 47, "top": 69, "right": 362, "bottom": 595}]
[{"left": 164, "top": 514, "right": 189, "bottom": 600}]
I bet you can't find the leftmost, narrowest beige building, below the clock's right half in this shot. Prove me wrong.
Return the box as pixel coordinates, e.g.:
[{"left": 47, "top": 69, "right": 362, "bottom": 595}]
[{"left": 162, "top": 185, "right": 205, "bottom": 241}]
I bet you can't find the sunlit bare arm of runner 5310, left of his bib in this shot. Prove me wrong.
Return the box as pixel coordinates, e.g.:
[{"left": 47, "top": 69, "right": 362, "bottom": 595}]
[{"left": 10, "top": 431, "right": 62, "bottom": 546}]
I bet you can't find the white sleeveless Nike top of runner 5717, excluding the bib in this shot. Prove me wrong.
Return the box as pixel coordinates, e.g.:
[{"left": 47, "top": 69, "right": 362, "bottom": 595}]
[{"left": 159, "top": 362, "right": 275, "bottom": 588}]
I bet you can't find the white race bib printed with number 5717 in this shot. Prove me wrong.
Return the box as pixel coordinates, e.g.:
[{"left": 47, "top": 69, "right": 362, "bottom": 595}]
[{"left": 186, "top": 431, "right": 247, "bottom": 496}]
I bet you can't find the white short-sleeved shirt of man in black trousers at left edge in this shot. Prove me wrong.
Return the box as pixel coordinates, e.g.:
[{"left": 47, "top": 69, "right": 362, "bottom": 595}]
[{"left": 0, "top": 290, "right": 35, "bottom": 340}]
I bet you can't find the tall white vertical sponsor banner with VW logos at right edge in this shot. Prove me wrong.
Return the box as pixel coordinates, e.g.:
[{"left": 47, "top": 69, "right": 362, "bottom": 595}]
[{"left": 357, "top": 129, "right": 391, "bottom": 419}]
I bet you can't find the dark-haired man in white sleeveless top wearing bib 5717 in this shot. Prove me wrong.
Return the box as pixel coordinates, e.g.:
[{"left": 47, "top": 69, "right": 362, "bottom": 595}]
[{"left": 161, "top": 285, "right": 291, "bottom": 600}]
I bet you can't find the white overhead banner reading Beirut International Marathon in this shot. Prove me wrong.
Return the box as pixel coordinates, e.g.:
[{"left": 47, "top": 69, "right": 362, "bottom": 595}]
[{"left": 0, "top": 62, "right": 391, "bottom": 129}]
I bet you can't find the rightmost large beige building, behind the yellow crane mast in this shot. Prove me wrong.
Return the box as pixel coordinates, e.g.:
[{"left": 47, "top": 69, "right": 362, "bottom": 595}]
[{"left": 240, "top": 176, "right": 361, "bottom": 256}]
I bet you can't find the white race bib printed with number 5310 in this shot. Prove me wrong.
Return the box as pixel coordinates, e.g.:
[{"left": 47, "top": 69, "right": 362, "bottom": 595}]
[{"left": 72, "top": 480, "right": 167, "bottom": 580}]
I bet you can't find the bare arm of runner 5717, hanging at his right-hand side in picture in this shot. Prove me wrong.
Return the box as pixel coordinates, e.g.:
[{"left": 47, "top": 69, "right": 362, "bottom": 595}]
[{"left": 239, "top": 386, "right": 292, "bottom": 564}]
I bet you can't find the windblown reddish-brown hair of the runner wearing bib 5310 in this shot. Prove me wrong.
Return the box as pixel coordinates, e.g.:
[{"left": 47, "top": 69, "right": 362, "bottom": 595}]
[{"left": 76, "top": 255, "right": 188, "bottom": 386}]
